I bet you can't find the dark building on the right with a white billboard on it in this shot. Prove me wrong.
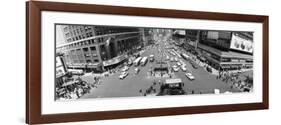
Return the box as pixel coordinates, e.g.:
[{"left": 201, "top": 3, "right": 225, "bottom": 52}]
[{"left": 197, "top": 31, "right": 253, "bottom": 70}]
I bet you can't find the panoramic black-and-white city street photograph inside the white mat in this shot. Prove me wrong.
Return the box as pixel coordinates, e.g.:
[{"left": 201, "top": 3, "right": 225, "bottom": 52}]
[{"left": 54, "top": 23, "right": 255, "bottom": 101}]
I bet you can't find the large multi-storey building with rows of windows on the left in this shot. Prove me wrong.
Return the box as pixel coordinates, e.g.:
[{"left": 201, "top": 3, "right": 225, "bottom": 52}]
[{"left": 56, "top": 25, "right": 141, "bottom": 72}]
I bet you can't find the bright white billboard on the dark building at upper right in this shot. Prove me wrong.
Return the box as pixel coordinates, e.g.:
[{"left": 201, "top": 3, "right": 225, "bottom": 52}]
[{"left": 230, "top": 34, "right": 253, "bottom": 53}]
